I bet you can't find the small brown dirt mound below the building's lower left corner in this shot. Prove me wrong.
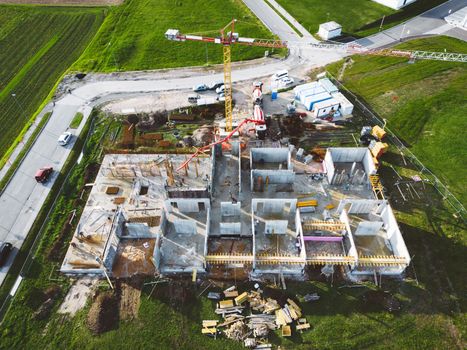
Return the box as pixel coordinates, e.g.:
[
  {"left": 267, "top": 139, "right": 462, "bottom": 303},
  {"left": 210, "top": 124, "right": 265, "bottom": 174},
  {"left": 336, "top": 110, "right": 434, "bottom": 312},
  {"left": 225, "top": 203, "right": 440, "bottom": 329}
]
[{"left": 86, "top": 292, "right": 119, "bottom": 334}]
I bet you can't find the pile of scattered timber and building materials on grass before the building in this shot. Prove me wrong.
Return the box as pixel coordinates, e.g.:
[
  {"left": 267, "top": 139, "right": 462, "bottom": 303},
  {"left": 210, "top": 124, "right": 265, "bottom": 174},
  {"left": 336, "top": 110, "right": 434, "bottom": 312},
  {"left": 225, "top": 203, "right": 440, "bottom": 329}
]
[{"left": 202, "top": 286, "right": 310, "bottom": 349}]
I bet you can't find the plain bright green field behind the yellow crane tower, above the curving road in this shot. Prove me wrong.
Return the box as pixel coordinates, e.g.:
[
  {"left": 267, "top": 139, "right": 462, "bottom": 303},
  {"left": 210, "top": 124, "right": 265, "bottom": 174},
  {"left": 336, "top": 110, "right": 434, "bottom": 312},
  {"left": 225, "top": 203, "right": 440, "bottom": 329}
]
[{"left": 74, "top": 0, "right": 282, "bottom": 72}]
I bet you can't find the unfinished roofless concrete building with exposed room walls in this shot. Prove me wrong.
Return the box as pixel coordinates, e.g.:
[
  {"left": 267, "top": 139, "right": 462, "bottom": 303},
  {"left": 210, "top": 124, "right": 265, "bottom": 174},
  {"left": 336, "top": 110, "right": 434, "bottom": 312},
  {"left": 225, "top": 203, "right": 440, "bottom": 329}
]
[{"left": 61, "top": 137, "right": 410, "bottom": 278}]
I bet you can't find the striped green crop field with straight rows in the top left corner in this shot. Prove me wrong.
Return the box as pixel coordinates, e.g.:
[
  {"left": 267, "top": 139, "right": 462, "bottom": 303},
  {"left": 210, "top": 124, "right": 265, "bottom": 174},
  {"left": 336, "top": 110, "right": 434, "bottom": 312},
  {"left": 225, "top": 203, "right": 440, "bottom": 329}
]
[{"left": 0, "top": 6, "right": 104, "bottom": 158}]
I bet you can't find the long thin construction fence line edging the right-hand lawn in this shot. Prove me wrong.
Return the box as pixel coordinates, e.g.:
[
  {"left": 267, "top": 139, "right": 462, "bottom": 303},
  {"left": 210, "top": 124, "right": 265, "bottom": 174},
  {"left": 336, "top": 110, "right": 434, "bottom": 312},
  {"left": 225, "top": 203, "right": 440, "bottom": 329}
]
[{"left": 327, "top": 72, "right": 467, "bottom": 222}]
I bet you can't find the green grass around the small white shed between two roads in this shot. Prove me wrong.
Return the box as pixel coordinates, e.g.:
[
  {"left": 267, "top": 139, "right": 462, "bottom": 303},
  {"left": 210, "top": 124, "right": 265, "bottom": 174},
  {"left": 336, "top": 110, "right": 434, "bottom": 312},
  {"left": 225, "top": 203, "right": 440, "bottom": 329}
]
[{"left": 277, "top": 0, "right": 444, "bottom": 36}]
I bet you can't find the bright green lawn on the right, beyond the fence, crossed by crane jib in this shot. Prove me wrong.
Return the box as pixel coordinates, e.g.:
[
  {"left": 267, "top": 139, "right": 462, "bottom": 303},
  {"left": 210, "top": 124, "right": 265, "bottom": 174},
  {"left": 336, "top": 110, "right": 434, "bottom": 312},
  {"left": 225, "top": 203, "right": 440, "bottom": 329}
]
[{"left": 328, "top": 37, "right": 467, "bottom": 206}]
